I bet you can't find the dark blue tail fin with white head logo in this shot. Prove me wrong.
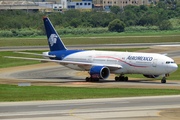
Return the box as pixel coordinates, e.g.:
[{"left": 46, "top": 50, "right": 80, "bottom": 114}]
[{"left": 43, "top": 17, "right": 66, "bottom": 51}]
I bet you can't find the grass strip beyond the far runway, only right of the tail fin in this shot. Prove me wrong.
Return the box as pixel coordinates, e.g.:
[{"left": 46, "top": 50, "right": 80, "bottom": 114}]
[{"left": 63, "top": 36, "right": 180, "bottom": 45}]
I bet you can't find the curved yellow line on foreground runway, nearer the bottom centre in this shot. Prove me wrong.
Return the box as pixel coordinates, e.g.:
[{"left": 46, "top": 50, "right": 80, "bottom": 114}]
[{"left": 69, "top": 102, "right": 129, "bottom": 120}]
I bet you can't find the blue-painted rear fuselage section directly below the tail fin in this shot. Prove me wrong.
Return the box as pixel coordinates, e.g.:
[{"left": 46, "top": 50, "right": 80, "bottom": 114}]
[{"left": 49, "top": 50, "right": 85, "bottom": 60}]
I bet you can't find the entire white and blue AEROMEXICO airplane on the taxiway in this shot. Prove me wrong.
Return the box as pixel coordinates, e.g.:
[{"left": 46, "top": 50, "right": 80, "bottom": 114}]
[{"left": 6, "top": 17, "right": 178, "bottom": 83}]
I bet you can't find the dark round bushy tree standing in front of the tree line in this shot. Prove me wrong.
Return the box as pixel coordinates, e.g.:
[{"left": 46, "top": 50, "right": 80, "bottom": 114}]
[{"left": 108, "top": 19, "right": 125, "bottom": 32}]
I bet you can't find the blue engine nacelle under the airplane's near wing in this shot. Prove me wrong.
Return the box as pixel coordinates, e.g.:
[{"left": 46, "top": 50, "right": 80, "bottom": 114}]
[{"left": 89, "top": 66, "right": 110, "bottom": 79}]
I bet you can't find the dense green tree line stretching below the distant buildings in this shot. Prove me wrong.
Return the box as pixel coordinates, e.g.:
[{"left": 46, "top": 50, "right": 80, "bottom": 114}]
[{"left": 0, "top": 0, "right": 180, "bottom": 30}]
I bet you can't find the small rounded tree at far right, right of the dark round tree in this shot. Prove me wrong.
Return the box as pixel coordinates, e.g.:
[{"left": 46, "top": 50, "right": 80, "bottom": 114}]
[{"left": 159, "top": 20, "right": 173, "bottom": 30}]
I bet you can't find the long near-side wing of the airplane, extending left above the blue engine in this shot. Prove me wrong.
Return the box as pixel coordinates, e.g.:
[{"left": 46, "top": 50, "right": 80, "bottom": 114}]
[{"left": 4, "top": 56, "right": 123, "bottom": 69}]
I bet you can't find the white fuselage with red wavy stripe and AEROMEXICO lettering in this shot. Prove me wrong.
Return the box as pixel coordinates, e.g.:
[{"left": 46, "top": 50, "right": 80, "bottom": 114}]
[{"left": 63, "top": 50, "right": 177, "bottom": 75}]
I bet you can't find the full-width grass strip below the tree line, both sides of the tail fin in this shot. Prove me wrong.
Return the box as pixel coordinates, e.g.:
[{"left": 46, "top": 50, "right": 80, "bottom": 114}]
[{"left": 0, "top": 32, "right": 180, "bottom": 47}]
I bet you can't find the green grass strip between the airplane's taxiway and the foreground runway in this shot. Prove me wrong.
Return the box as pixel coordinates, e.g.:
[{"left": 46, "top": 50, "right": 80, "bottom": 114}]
[{"left": 0, "top": 84, "right": 180, "bottom": 102}]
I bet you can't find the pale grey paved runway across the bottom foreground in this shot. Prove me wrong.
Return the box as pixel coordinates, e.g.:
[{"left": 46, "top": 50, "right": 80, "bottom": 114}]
[{"left": 0, "top": 95, "right": 180, "bottom": 120}]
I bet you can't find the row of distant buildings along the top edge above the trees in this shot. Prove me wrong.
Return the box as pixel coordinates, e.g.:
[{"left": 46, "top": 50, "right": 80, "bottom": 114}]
[{"left": 0, "top": 0, "right": 159, "bottom": 12}]
